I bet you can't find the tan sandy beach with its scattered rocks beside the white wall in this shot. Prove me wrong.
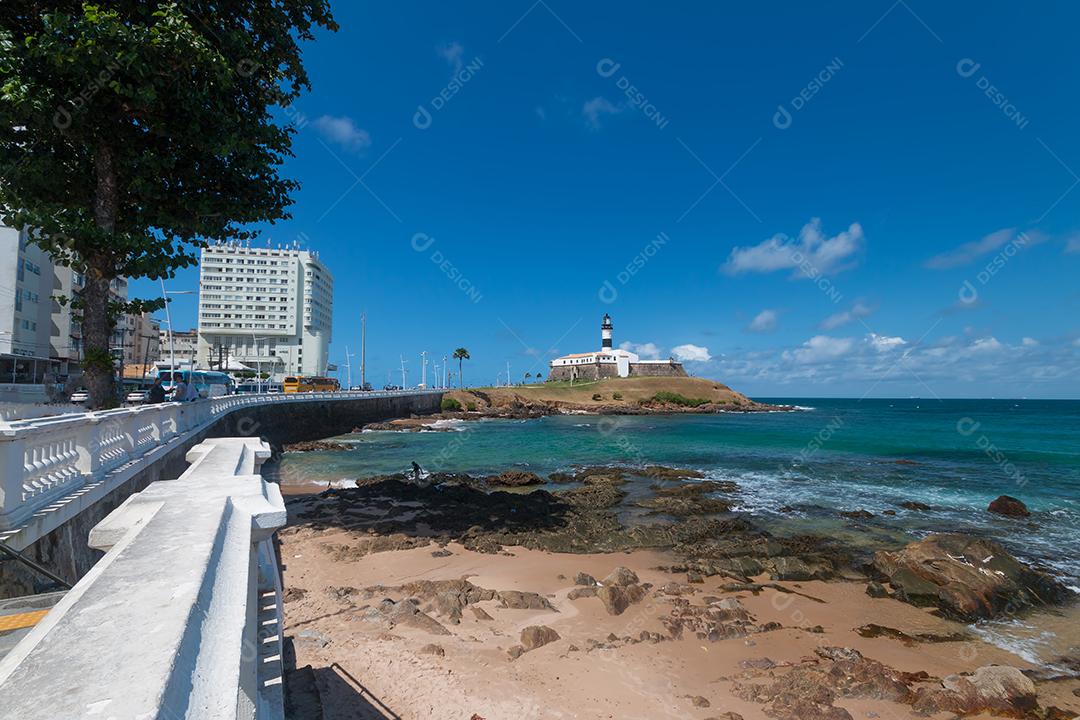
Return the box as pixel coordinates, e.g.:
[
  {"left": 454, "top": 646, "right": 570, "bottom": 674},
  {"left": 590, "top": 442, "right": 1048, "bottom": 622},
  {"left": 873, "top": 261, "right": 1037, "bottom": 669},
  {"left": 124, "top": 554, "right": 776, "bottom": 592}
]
[{"left": 281, "top": 468, "right": 1080, "bottom": 720}]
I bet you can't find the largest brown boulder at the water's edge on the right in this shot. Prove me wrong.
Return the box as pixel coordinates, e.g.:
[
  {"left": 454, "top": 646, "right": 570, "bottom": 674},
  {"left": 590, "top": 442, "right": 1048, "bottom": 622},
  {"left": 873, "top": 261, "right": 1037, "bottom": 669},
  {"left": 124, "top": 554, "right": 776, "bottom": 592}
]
[{"left": 874, "top": 534, "right": 1069, "bottom": 621}]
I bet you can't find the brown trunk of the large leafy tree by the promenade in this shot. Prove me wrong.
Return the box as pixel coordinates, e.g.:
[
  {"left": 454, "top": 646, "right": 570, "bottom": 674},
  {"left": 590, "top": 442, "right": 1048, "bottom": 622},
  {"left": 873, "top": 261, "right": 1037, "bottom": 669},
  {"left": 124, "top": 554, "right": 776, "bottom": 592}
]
[{"left": 82, "top": 142, "right": 119, "bottom": 409}]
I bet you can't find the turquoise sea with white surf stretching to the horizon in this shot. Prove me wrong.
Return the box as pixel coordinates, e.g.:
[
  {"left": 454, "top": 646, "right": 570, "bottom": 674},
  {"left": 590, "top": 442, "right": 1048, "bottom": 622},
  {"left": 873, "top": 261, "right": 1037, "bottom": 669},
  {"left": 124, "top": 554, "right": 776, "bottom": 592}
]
[{"left": 272, "top": 398, "right": 1080, "bottom": 585}]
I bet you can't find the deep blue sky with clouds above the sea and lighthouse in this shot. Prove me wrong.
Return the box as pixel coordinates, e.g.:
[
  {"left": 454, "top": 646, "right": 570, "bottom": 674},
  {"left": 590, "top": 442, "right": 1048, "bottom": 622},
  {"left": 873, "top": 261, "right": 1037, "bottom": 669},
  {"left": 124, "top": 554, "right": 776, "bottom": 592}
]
[{"left": 134, "top": 0, "right": 1080, "bottom": 397}]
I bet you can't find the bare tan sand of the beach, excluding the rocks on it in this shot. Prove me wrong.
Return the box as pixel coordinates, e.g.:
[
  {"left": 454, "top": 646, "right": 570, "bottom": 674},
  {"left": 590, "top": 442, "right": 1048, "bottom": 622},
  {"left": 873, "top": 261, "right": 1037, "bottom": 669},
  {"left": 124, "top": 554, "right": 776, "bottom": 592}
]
[{"left": 281, "top": 526, "right": 1080, "bottom": 720}]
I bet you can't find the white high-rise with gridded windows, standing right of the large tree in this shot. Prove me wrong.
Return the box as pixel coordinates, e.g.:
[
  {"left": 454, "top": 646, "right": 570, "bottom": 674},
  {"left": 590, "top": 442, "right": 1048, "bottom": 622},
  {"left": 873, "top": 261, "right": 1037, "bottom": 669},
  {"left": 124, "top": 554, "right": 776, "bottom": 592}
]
[{"left": 196, "top": 243, "right": 334, "bottom": 379}]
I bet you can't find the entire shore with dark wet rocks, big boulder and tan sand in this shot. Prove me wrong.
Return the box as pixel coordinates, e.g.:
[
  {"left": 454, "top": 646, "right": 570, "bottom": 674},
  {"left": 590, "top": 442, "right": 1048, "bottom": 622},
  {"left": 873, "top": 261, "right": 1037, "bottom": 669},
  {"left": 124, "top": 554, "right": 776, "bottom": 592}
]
[{"left": 282, "top": 466, "right": 1080, "bottom": 720}]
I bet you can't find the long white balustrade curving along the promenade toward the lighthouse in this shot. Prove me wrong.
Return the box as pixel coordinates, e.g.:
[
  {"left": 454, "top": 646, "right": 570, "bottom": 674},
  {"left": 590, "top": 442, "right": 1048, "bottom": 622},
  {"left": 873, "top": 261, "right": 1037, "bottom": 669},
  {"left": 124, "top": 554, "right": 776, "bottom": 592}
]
[{"left": 0, "top": 390, "right": 442, "bottom": 549}]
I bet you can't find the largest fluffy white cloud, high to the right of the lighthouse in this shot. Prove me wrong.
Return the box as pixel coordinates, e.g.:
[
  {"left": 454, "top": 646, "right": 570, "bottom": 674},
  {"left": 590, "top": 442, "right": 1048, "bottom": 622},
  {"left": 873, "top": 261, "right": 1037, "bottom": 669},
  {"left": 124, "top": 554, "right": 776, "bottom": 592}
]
[{"left": 720, "top": 218, "right": 864, "bottom": 277}]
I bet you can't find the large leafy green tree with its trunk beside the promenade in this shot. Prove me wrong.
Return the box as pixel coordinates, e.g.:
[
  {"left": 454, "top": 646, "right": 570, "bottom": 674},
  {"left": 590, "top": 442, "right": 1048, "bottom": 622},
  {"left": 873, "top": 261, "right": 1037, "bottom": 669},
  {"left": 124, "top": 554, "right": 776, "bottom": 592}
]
[{"left": 0, "top": 0, "right": 337, "bottom": 407}]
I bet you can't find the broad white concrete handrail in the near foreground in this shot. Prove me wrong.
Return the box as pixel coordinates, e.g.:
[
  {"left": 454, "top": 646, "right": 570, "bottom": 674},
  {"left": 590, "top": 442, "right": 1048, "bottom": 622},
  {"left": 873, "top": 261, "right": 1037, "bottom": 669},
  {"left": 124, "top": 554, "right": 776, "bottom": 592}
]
[{"left": 0, "top": 438, "right": 286, "bottom": 720}]
